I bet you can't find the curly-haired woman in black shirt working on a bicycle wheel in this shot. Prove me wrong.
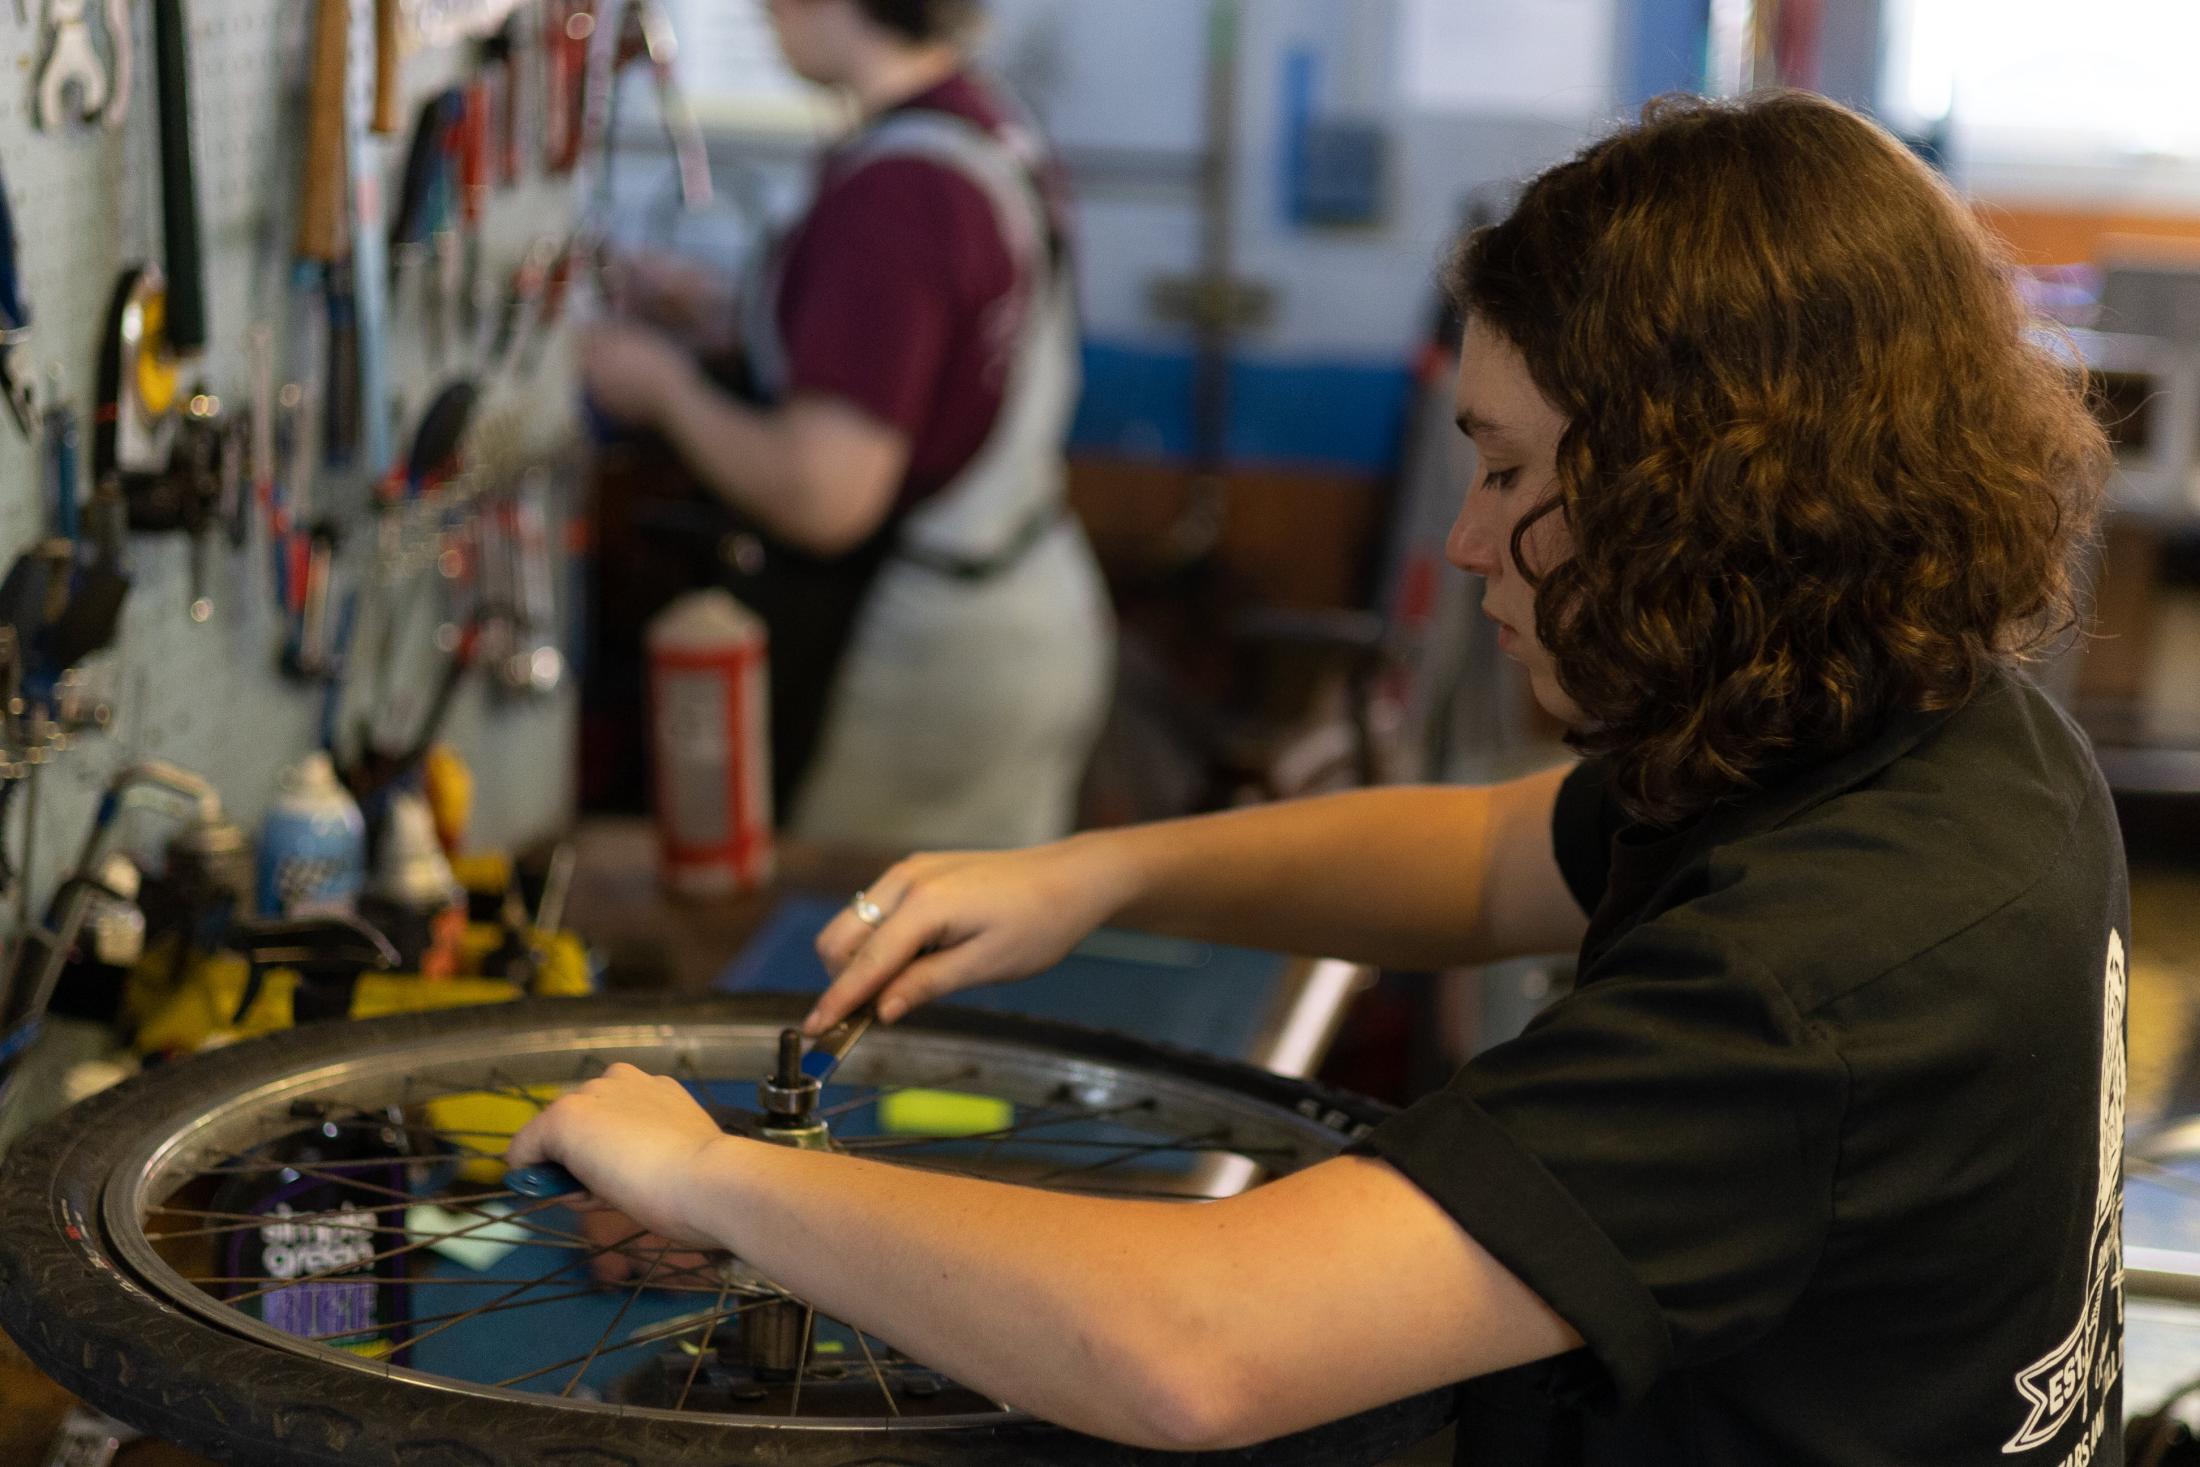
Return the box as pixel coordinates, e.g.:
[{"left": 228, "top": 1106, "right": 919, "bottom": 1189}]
[{"left": 515, "top": 95, "right": 2130, "bottom": 1467}]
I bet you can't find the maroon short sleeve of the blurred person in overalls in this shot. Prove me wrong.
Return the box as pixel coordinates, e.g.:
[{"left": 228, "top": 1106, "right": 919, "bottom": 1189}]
[{"left": 779, "top": 158, "right": 1014, "bottom": 440}]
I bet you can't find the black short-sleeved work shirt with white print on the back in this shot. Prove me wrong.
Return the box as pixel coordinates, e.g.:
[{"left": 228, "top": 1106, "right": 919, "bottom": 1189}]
[{"left": 1366, "top": 673, "right": 2130, "bottom": 1467}]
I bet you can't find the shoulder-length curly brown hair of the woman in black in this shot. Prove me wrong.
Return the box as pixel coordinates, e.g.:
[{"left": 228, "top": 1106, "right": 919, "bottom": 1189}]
[{"left": 1448, "top": 92, "right": 2110, "bottom": 825}]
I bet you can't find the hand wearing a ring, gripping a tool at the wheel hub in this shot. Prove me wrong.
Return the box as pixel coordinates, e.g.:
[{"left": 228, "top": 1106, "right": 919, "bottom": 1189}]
[{"left": 803, "top": 836, "right": 1131, "bottom": 1034}]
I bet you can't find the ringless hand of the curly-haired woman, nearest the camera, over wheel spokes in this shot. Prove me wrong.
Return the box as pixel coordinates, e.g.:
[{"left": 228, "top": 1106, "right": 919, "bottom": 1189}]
[{"left": 504, "top": 1065, "right": 733, "bottom": 1247}]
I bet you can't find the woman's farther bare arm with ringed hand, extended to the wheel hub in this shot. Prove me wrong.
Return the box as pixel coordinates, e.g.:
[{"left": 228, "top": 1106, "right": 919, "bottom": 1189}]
[{"left": 807, "top": 770, "right": 1588, "bottom": 1032}]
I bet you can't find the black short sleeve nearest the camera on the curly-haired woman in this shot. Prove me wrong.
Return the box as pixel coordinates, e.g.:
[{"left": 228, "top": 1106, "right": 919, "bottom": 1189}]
[{"left": 1364, "top": 919, "right": 1848, "bottom": 1403}]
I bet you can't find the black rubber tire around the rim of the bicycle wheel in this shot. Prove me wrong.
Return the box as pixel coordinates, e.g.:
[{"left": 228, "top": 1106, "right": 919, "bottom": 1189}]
[{"left": 0, "top": 994, "right": 1452, "bottom": 1467}]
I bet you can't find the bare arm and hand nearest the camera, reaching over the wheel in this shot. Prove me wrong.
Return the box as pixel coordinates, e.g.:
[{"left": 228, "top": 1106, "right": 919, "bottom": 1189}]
[{"left": 510, "top": 1067, "right": 1580, "bottom": 1452}]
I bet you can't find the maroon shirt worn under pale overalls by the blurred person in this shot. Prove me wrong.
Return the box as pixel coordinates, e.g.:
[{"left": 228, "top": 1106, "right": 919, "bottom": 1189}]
[{"left": 779, "top": 73, "right": 1065, "bottom": 504}]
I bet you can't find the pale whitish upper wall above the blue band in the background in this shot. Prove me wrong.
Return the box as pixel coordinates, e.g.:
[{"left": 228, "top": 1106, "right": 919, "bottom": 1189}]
[{"left": 992, "top": 0, "right": 1619, "bottom": 359}]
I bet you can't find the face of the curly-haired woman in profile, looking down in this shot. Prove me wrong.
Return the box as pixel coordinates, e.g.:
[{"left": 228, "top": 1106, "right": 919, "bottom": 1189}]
[{"left": 1443, "top": 321, "right": 1584, "bottom": 728}]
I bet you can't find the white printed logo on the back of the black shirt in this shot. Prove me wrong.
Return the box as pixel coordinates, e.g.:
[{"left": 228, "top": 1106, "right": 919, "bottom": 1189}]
[{"left": 2002, "top": 930, "right": 2125, "bottom": 1458}]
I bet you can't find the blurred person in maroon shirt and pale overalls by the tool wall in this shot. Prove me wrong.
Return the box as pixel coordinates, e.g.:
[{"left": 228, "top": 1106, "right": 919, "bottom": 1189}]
[{"left": 583, "top": 0, "right": 1113, "bottom": 849}]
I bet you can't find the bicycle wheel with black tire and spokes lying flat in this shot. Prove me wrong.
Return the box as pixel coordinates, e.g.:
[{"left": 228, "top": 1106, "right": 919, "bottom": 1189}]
[{"left": 0, "top": 996, "right": 1452, "bottom": 1467}]
